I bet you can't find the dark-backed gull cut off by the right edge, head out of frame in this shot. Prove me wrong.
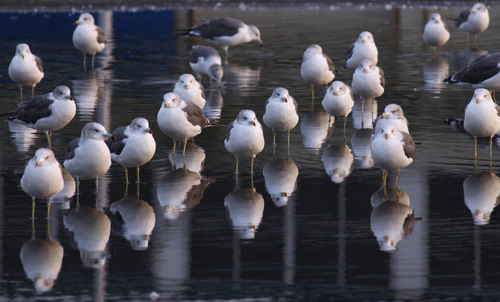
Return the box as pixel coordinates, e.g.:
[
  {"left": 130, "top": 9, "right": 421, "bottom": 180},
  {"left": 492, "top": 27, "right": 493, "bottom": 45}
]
[{"left": 444, "top": 52, "right": 500, "bottom": 100}]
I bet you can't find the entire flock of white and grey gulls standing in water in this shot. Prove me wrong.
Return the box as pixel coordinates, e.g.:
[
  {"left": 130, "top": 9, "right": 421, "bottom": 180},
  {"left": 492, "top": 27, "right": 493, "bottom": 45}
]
[{"left": 4, "top": 3, "right": 500, "bottom": 286}]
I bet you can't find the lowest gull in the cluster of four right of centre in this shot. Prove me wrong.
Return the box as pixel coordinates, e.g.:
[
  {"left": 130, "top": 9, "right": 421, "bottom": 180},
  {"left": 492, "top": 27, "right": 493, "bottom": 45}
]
[{"left": 321, "top": 81, "right": 354, "bottom": 131}]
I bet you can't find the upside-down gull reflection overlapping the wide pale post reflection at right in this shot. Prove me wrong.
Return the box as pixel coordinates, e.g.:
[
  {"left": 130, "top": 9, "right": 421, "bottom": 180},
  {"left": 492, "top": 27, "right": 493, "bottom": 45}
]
[{"left": 370, "top": 172, "right": 416, "bottom": 252}]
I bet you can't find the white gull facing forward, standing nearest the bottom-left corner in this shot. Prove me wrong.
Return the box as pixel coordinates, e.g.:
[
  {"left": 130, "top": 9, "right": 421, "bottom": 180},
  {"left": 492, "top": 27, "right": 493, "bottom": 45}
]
[{"left": 21, "top": 148, "right": 64, "bottom": 206}]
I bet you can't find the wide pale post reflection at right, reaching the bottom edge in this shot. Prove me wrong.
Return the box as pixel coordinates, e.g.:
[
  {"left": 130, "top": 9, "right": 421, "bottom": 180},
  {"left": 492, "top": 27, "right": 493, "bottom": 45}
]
[{"left": 390, "top": 169, "right": 429, "bottom": 300}]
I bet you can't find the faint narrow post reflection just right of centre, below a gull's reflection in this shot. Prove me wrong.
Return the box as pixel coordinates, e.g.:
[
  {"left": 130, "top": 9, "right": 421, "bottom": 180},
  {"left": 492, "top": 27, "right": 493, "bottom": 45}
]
[{"left": 283, "top": 195, "right": 295, "bottom": 285}]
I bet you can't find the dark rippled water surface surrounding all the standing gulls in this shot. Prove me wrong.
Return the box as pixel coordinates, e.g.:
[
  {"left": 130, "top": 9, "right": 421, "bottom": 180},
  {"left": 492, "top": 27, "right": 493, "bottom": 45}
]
[{"left": 0, "top": 6, "right": 500, "bottom": 301}]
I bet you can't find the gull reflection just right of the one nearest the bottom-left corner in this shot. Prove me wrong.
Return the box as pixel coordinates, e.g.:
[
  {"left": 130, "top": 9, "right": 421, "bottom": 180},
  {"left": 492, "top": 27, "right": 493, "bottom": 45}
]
[{"left": 63, "top": 206, "right": 111, "bottom": 268}]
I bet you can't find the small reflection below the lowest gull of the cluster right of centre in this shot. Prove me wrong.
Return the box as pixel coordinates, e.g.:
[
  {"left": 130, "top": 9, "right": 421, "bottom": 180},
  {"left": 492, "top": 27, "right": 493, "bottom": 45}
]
[{"left": 321, "top": 145, "right": 354, "bottom": 184}]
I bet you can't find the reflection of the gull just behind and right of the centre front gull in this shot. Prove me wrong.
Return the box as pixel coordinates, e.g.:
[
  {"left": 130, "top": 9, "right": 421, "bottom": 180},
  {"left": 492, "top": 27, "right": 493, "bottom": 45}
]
[{"left": 262, "top": 159, "right": 299, "bottom": 207}]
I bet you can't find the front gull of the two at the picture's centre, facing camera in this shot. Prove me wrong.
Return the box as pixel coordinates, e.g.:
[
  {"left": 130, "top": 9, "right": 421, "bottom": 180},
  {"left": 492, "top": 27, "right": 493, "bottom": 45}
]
[{"left": 224, "top": 110, "right": 265, "bottom": 174}]
